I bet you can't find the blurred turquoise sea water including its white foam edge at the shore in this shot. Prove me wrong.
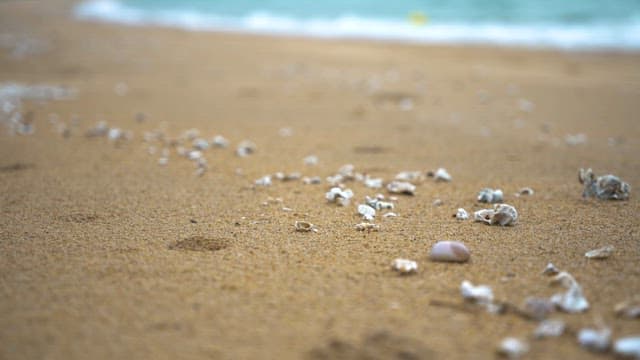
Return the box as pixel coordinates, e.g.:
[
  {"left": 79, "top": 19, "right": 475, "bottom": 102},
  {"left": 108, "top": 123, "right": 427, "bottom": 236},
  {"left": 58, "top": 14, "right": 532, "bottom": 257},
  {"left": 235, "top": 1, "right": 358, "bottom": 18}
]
[{"left": 75, "top": 0, "right": 640, "bottom": 51}]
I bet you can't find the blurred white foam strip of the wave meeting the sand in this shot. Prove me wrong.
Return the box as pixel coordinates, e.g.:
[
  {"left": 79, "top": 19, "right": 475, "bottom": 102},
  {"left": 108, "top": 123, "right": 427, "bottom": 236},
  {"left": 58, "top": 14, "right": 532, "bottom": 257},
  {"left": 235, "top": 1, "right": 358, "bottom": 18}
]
[{"left": 75, "top": 0, "right": 640, "bottom": 51}]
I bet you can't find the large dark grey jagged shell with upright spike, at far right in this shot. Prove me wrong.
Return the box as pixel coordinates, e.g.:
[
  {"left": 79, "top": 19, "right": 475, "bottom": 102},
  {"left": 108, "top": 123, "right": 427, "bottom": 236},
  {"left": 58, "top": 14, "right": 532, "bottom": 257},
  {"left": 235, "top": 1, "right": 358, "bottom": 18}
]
[{"left": 578, "top": 169, "right": 631, "bottom": 200}]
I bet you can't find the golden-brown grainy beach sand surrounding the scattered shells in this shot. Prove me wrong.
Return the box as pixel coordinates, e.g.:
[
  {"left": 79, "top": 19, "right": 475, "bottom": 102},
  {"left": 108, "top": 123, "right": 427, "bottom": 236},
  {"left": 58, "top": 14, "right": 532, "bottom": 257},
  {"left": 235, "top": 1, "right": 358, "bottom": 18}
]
[{"left": 0, "top": 1, "right": 640, "bottom": 359}]
